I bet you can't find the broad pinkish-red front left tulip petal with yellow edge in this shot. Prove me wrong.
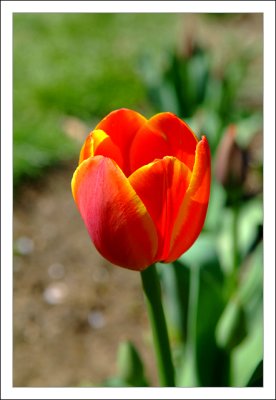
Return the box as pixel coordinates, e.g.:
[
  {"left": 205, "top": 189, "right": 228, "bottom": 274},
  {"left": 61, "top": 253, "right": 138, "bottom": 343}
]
[{"left": 72, "top": 156, "right": 158, "bottom": 270}]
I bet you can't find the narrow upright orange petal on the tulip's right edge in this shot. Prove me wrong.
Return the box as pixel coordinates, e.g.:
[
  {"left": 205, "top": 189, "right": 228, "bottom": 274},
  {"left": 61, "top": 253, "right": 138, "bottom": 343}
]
[{"left": 165, "top": 137, "right": 211, "bottom": 262}]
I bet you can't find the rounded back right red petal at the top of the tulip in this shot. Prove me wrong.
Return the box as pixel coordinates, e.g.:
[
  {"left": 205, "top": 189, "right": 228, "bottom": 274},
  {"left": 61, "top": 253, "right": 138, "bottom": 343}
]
[{"left": 130, "top": 112, "right": 198, "bottom": 171}]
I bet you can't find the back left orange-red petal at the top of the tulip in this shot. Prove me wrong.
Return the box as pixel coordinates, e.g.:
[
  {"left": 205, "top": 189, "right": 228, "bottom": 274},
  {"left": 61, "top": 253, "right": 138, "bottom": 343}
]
[{"left": 96, "top": 108, "right": 147, "bottom": 176}]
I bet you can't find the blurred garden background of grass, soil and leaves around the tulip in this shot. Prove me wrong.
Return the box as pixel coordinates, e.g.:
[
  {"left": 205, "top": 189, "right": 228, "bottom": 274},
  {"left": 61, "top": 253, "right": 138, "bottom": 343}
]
[{"left": 13, "top": 13, "right": 263, "bottom": 387}]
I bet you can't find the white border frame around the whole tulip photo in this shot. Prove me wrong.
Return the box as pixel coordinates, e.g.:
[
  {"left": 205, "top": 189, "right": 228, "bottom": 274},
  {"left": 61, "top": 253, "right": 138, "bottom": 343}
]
[{"left": 1, "top": 1, "right": 275, "bottom": 399}]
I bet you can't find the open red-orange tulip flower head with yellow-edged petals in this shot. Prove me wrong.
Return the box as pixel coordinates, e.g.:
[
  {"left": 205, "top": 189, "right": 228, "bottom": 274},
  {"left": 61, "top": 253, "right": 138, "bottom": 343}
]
[{"left": 72, "top": 109, "right": 211, "bottom": 271}]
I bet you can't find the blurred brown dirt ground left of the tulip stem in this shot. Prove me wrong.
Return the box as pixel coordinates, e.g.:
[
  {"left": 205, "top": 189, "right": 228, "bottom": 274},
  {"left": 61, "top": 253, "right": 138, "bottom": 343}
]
[{"left": 13, "top": 164, "right": 157, "bottom": 387}]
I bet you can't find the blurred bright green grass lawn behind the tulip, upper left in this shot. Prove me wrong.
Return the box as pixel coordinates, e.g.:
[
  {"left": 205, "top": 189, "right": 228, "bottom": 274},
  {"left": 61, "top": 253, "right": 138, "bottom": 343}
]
[{"left": 13, "top": 13, "right": 181, "bottom": 185}]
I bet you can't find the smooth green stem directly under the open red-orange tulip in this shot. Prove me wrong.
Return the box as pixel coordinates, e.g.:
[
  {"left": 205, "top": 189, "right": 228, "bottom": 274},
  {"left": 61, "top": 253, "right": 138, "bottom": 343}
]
[{"left": 141, "top": 264, "right": 175, "bottom": 387}]
